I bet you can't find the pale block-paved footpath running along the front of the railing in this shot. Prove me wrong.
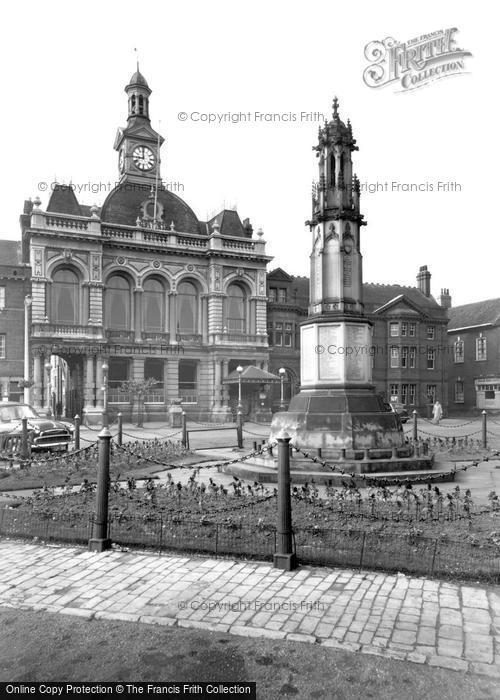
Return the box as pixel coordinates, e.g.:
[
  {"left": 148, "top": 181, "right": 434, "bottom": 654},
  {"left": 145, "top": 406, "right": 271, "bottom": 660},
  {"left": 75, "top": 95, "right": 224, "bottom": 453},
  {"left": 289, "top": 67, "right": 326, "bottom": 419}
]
[{"left": 0, "top": 540, "right": 500, "bottom": 678}]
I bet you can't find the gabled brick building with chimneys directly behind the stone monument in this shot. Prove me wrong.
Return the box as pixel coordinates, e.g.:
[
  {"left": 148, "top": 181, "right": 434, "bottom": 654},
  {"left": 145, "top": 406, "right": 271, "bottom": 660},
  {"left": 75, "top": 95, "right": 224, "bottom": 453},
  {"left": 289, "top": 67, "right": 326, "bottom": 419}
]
[{"left": 267, "top": 266, "right": 451, "bottom": 414}]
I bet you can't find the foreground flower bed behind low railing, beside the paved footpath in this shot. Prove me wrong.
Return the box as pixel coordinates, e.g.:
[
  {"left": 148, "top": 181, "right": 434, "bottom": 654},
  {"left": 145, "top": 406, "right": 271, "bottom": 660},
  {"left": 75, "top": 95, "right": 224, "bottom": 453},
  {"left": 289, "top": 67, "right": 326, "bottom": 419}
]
[{"left": 0, "top": 478, "right": 500, "bottom": 582}]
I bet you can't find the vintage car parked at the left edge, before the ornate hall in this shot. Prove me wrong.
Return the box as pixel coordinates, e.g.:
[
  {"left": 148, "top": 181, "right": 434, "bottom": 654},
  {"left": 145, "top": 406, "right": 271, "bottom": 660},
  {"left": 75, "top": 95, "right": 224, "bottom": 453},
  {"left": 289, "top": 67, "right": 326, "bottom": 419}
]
[{"left": 0, "top": 401, "right": 73, "bottom": 452}]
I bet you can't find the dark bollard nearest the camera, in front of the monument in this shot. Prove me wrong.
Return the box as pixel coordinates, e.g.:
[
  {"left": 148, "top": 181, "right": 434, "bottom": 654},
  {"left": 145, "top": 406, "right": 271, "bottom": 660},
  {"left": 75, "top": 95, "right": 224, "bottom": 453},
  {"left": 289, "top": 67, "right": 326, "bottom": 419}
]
[{"left": 273, "top": 431, "right": 297, "bottom": 571}]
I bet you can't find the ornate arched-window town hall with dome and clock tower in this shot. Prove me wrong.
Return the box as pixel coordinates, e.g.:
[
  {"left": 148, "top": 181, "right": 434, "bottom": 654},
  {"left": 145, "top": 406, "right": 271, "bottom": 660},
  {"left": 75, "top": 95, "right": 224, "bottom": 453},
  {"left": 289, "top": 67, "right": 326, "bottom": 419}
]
[{"left": 21, "top": 70, "right": 270, "bottom": 421}]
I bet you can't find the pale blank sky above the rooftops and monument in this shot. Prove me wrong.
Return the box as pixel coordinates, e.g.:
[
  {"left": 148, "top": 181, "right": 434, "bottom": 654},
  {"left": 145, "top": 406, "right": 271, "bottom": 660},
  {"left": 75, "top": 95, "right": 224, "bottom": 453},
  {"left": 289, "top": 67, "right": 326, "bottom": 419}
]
[{"left": 0, "top": 0, "right": 492, "bottom": 305}]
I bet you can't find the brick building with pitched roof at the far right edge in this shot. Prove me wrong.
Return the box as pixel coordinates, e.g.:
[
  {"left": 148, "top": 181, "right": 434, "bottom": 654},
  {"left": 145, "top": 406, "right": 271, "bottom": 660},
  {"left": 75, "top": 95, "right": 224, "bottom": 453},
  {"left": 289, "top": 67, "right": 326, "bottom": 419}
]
[{"left": 448, "top": 299, "right": 500, "bottom": 413}]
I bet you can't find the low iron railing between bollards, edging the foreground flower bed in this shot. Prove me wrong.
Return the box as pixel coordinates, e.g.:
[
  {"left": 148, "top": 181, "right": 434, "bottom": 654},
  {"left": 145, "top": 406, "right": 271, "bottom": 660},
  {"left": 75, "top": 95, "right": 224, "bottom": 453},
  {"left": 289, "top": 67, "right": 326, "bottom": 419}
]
[{"left": 0, "top": 508, "right": 500, "bottom": 583}]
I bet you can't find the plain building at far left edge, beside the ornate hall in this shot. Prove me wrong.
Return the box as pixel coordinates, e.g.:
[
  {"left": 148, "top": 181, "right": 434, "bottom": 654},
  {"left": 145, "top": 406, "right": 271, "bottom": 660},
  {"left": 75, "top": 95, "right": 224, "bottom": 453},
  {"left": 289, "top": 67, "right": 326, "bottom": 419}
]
[{"left": 0, "top": 240, "right": 31, "bottom": 401}]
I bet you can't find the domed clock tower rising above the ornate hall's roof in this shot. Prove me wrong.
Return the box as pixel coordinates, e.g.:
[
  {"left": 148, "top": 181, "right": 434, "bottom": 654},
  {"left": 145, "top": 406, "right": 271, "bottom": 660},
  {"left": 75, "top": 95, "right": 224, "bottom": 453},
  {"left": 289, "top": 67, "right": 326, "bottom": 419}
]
[{"left": 114, "top": 65, "right": 164, "bottom": 185}]
